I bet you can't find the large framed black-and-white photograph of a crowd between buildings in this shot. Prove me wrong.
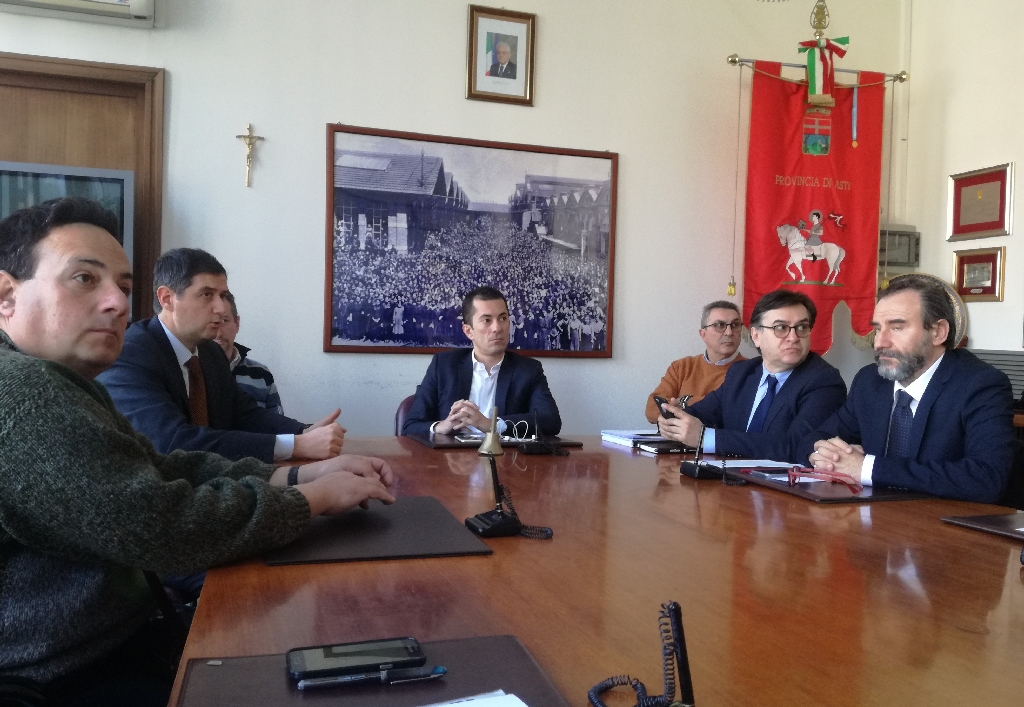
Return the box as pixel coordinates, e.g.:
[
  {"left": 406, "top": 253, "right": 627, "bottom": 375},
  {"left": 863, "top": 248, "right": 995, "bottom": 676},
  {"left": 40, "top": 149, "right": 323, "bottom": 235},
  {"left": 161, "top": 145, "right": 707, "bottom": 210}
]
[{"left": 324, "top": 125, "right": 618, "bottom": 358}]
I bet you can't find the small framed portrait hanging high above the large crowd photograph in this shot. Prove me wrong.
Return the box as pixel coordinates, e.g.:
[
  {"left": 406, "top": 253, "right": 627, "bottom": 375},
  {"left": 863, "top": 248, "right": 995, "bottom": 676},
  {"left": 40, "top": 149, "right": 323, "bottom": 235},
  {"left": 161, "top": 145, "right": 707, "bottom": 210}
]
[{"left": 466, "top": 5, "right": 537, "bottom": 106}]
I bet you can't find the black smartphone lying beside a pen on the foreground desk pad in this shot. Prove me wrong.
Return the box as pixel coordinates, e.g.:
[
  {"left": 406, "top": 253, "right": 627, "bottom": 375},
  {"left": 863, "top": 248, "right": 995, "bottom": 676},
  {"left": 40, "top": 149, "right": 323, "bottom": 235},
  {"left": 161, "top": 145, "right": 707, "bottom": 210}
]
[{"left": 288, "top": 637, "right": 427, "bottom": 680}]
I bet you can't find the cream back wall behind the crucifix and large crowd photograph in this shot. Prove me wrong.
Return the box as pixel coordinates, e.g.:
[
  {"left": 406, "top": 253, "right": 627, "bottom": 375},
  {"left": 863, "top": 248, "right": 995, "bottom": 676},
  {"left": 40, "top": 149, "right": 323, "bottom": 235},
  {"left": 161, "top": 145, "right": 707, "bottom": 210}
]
[{"left": 0, "top": 0, "right": 901, "bottom": 434}]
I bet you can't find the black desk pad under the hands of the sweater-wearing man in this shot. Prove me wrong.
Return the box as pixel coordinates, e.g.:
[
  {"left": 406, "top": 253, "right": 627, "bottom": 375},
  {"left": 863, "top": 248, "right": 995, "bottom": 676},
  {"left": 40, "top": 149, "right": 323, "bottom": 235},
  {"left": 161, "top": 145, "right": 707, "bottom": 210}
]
[{"left": 263, "top": 496, "right": 492, "bottom": 565}]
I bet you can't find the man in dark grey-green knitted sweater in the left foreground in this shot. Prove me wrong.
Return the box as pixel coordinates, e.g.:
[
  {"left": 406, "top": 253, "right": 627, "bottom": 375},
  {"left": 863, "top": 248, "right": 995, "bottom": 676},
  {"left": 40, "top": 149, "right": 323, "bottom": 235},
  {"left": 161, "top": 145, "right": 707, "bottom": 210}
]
[{"left": 0, "top": 198, "right": 394, "bottom": 705}]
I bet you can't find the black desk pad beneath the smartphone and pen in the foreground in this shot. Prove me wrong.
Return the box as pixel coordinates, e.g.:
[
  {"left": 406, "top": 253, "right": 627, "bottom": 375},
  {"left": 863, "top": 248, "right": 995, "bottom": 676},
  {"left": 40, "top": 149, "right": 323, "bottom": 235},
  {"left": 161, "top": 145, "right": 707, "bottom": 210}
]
[{"left": 177, "top": 636, "right": 568, "bottom": 707}]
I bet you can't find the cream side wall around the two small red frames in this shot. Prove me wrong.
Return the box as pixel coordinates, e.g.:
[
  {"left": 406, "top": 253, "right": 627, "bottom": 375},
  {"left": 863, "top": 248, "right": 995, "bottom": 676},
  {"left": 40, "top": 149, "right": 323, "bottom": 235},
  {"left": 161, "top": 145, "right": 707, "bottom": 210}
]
[{"left": 908, "top": 0, "right": 1024, "bottom": 350}]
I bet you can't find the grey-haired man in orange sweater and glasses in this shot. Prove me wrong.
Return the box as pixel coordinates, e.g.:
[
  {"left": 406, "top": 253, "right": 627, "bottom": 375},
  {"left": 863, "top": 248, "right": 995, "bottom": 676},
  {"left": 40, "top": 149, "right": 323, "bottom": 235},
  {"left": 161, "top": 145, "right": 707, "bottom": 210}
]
[{"left": 645, "top": 299, "right": 745, "bottom": 423}]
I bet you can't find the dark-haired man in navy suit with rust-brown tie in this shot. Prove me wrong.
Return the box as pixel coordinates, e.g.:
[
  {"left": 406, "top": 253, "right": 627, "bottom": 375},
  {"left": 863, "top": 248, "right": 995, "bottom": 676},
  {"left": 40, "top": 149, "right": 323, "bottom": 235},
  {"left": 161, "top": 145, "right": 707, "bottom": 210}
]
[{"left": 98, "top": 248, "right": 345, "bottom": 462}]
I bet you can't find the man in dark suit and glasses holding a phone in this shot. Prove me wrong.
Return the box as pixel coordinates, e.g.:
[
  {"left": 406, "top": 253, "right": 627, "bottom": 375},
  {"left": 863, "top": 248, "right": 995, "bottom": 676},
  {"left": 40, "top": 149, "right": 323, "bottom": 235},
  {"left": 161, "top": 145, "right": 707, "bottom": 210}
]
[{"left": 658, "top": 290, "right": 846, "bottom": 461}]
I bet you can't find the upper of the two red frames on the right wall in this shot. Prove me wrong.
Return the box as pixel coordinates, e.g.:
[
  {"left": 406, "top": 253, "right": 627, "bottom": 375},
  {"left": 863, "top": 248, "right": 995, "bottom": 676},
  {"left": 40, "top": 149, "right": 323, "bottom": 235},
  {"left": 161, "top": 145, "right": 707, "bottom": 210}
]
[{"left": 946, "top": 162, "right": 1014, "bottom": 241}]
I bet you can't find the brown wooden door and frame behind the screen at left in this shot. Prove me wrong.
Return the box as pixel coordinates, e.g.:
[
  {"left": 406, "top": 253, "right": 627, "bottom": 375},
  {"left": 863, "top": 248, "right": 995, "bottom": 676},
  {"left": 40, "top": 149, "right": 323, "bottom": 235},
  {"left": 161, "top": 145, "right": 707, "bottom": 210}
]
[{"left": 0, "top": 52, "right": 164, "bottom": 319}]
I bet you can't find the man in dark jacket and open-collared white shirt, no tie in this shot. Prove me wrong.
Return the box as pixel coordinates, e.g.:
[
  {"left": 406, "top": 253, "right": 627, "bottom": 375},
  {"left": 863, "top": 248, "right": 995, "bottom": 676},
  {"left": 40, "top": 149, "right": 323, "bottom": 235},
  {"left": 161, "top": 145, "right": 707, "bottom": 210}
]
[{"left": 401, "top": 287, "right": 562, "bottom": 436}]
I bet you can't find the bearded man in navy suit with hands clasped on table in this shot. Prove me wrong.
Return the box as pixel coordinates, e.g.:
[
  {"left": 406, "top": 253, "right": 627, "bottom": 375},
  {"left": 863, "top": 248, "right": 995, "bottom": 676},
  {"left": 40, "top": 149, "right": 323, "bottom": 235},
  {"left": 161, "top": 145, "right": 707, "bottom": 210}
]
[{"left": 800, "top": 275, "right": 1014, "bottom": 503}]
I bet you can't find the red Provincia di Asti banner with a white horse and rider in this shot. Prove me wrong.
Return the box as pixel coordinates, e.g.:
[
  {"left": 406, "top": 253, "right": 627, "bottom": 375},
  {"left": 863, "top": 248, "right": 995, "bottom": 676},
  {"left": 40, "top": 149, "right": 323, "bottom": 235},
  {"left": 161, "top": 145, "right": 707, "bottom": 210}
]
[{"left": 743, "top": 61, "right": 885, "bottom": 354}]
